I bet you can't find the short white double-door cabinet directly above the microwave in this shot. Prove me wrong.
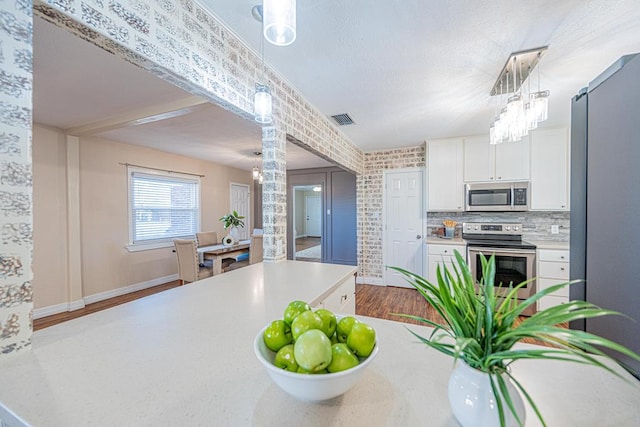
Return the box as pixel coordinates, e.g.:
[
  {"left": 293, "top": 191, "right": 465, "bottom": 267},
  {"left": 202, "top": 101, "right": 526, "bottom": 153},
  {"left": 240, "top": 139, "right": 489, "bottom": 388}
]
[{"left": 464, "top": 133, "right": 530, "bottom": 182}]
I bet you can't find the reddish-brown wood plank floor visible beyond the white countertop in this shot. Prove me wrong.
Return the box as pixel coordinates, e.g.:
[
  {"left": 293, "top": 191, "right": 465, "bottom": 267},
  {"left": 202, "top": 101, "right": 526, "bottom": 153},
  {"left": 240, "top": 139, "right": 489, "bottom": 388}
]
[{"left": 33, "top": 280, "right": 556, "bottom": 344}]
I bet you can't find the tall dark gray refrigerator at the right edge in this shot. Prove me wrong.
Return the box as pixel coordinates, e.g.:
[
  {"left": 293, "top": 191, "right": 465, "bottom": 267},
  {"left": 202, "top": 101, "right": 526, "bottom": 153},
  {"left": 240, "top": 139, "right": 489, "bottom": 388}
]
[{"left": 570, "top": 54, "right": 640, "bottom": 378}]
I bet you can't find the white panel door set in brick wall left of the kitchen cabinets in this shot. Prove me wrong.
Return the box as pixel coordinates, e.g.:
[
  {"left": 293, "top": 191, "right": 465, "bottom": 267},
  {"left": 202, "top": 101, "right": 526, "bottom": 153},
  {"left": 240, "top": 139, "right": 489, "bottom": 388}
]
[{"left": 383, "top": 170, "right": 426, "bottom": 287}]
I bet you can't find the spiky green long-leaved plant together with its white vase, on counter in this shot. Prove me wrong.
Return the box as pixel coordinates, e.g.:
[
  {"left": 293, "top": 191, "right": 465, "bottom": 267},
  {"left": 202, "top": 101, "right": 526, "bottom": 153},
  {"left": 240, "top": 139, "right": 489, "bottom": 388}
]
[{"left": 390, "top": 251, "right": 640, "bottom": 426}]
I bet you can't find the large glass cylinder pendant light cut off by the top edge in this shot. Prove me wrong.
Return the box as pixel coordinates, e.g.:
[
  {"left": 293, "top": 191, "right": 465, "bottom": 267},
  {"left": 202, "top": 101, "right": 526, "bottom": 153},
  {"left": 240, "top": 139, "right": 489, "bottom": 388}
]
[{"left": 262, "top": 0, "right": 296, "bottom": 46}]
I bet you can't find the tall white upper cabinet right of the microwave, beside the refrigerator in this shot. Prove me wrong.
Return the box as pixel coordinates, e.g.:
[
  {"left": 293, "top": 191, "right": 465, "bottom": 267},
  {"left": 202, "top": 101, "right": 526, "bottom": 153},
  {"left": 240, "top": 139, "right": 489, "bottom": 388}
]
[{"left": 531, "top": 128, "right": 569, "bottom": 211}]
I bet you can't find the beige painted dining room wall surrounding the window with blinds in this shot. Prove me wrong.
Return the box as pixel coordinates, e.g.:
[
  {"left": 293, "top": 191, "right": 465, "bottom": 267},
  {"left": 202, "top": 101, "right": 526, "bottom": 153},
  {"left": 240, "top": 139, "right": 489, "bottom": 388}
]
[{"left": 33, "top": 125, "right": 252, "bottom": 308}]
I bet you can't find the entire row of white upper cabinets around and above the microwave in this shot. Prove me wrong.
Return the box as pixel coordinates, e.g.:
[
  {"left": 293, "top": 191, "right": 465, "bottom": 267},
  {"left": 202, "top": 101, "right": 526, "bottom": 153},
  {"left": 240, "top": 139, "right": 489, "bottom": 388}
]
[{"left": 427, "top": 128, "right": 570, "bottom": 212}]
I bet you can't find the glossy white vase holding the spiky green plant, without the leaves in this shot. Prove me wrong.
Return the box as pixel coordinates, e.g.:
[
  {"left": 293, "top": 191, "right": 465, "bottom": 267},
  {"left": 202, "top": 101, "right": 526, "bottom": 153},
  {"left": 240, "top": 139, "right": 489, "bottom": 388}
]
[{"left": 449, "top": 360, "right": 526, "bottom": 427}]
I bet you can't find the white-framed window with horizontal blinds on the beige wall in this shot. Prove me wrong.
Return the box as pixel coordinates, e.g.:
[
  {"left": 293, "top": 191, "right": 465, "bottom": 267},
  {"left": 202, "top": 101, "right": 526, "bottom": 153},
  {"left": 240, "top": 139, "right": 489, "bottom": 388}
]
[{"left": 128, "top": 167, "right": 200, "bottom": 247}]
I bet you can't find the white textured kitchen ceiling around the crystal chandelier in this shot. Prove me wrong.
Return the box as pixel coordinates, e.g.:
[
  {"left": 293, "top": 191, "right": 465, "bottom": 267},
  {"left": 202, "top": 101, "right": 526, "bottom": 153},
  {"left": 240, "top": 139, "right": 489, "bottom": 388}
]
[{"left": 200, "top": 0, "right": 640, "bottom": 151}]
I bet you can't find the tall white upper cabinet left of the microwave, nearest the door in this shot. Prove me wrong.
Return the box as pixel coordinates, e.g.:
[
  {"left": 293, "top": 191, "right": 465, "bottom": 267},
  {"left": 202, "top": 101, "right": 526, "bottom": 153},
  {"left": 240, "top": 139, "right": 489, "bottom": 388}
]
[{"left": 427, "top": 138, "right": 464, "bottom": 212}]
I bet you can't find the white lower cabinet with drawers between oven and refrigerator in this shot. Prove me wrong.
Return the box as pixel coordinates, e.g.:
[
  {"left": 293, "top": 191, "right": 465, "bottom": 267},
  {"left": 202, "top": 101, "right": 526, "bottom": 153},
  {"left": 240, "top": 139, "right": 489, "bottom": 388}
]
[{"left": 536, "top": 249, "right": 569, "bottom": 310}]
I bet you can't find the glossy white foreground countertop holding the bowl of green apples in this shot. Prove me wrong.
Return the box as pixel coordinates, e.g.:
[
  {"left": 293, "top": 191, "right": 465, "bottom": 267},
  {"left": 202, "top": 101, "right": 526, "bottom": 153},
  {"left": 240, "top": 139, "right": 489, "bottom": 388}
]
[{"left": 0, "top": 261, "right": 640, "bottom": 426}]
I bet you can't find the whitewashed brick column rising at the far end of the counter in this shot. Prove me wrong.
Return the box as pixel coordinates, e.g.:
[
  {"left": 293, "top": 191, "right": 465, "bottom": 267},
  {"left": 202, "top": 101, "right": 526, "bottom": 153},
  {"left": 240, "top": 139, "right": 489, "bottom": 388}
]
[{"left": 262, "top": 126, "right": 287, "bottom": 262}]
